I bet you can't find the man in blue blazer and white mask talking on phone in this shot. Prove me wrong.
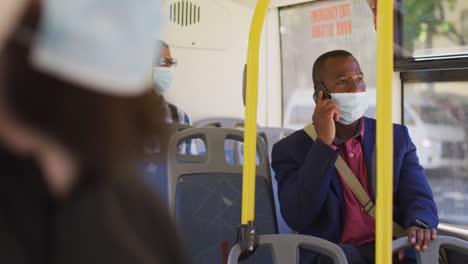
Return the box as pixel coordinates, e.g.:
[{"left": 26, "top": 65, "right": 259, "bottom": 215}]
[{"left": 272, "top": 50, "right": 438, "bottom": 263}]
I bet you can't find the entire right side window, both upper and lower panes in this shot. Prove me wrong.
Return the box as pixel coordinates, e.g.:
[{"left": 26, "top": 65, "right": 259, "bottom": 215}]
[{"left": 395, "top": 0, "right": 468, "bottom": 229}]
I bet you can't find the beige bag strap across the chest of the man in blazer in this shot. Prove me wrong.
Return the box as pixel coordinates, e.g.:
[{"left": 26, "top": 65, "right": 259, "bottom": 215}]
[{"left": 304, "top": 124, "right": 406, "bottom": 237}]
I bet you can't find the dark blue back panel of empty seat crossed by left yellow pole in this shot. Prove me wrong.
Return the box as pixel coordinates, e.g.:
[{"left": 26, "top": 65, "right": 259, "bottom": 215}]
[{"left": 176, "top": 174, "right": 277, "bottom": 264}]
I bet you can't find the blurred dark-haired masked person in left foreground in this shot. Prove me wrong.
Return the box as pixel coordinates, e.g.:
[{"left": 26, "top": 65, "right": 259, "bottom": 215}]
[{"left": 0, "top": 0, "right": 187, "bottom": 264}]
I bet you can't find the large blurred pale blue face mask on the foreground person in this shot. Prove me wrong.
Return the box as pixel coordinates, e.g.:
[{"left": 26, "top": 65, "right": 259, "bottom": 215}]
[{"left": 32, "top": 0, "right": 161, "bottom": 96}]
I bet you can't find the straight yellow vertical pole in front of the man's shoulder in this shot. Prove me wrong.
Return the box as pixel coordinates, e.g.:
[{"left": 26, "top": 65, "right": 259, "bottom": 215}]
[{"left": 375, "top": 0, "right": 394, "bottom": 264}]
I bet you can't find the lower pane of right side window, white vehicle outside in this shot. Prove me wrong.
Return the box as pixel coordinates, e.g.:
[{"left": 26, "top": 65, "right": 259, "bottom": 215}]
[{"left": 403, "top": 82, "right": 468, "bottom": 226}]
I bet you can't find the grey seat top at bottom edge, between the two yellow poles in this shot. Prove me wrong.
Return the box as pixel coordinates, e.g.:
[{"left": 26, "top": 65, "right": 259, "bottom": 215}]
[{"left": 228, "top": 235, "right": 348, "bottom": 264}]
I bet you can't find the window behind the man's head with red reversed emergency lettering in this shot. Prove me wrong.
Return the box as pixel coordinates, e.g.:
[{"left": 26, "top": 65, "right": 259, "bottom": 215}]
[{"left": 279, "top": 0, "right": 376, "bottom": 129}]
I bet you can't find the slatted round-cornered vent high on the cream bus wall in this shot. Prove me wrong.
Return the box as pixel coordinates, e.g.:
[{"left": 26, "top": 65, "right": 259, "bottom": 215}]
[{"left": 169, "top": 1, "right": 200, "bottom": 27}]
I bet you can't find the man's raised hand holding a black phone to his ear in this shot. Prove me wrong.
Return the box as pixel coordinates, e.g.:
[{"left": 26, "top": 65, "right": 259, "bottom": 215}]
[{"left": 312, "top": 92, "right": 340, "bottom": 145}]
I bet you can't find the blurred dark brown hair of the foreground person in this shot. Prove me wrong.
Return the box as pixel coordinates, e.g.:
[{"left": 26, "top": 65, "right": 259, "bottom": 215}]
[{"left": 0, "top": 1, "right": 165, "bottom": 177}]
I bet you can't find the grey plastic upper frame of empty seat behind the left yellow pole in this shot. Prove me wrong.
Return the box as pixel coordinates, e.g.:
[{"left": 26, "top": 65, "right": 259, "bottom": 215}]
[{"left": 167, "top": 127, "right": 271, "bottom": 219}]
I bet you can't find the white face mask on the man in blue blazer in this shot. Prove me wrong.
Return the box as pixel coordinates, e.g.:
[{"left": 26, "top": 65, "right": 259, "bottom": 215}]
[{"left": 331, "top": 92, "right": 369, "bottom": 125}]
